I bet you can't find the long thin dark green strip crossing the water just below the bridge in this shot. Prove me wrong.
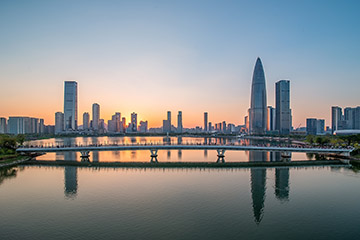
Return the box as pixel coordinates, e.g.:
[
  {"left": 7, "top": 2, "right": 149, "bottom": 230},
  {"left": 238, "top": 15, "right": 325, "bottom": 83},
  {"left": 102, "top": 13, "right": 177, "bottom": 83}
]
[{"left": 21, "top": 160, "right": 347, "bottom": 168}]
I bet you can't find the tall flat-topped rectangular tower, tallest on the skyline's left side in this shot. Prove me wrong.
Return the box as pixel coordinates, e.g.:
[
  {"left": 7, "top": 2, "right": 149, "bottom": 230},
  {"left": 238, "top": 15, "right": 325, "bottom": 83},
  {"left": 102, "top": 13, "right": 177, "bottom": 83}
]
[{"left": 64, "top": 81, "right": 78, "bottom": 131}]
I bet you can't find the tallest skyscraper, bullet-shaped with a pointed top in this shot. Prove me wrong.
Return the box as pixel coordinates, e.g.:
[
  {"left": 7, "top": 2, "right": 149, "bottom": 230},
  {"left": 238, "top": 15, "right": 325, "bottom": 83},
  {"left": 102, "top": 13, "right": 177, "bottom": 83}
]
[{"left": 249, "top": 58, "right": 267, "bottom": 134}]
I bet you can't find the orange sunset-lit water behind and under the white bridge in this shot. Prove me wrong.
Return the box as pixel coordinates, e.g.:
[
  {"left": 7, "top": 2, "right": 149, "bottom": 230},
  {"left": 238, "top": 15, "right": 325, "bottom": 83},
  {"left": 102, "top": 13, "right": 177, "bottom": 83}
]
[{"left": 27, "top": 137, "right": 315, "bottom": 162}]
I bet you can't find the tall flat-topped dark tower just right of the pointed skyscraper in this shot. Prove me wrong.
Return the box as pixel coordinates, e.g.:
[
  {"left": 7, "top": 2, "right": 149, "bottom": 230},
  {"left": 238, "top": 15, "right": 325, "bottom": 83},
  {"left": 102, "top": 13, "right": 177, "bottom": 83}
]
[{"left": 275, "top": 80, "right": 292, "bottom": 134}]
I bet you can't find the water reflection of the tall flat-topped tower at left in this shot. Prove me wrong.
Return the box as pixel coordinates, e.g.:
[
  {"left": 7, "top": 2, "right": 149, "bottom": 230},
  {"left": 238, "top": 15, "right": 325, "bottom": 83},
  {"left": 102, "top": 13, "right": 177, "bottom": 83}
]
[{"left": 56, "top": 152, "right": 78, "bottom": 199}]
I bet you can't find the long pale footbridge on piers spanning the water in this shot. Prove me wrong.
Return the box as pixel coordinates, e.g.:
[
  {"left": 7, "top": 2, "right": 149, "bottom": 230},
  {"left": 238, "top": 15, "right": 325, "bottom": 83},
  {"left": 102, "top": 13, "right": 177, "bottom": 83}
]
[{"left": 16, "top": 143, "right": 353, "bottom": 162}]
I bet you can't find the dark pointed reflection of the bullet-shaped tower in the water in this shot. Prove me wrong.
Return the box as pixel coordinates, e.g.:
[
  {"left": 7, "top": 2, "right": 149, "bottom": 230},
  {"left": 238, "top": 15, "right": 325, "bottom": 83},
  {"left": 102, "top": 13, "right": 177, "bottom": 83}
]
[{"left": 249, "top": 151, "right": 268, "bottom": 224}]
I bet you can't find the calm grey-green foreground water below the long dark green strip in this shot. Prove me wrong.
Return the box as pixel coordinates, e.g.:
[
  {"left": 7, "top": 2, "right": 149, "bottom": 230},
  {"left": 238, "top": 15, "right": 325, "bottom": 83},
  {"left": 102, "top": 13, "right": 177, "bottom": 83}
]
[{"left": 0, "top": 138, "right": 360, "bottom": 240}]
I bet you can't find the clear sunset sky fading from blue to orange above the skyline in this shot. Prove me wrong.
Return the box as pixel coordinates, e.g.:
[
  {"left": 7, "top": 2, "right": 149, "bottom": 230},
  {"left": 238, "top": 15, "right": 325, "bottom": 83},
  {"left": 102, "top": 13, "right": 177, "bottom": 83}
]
[{"left": 0, "top": 0, "right": 360, "bottom": 128}]
